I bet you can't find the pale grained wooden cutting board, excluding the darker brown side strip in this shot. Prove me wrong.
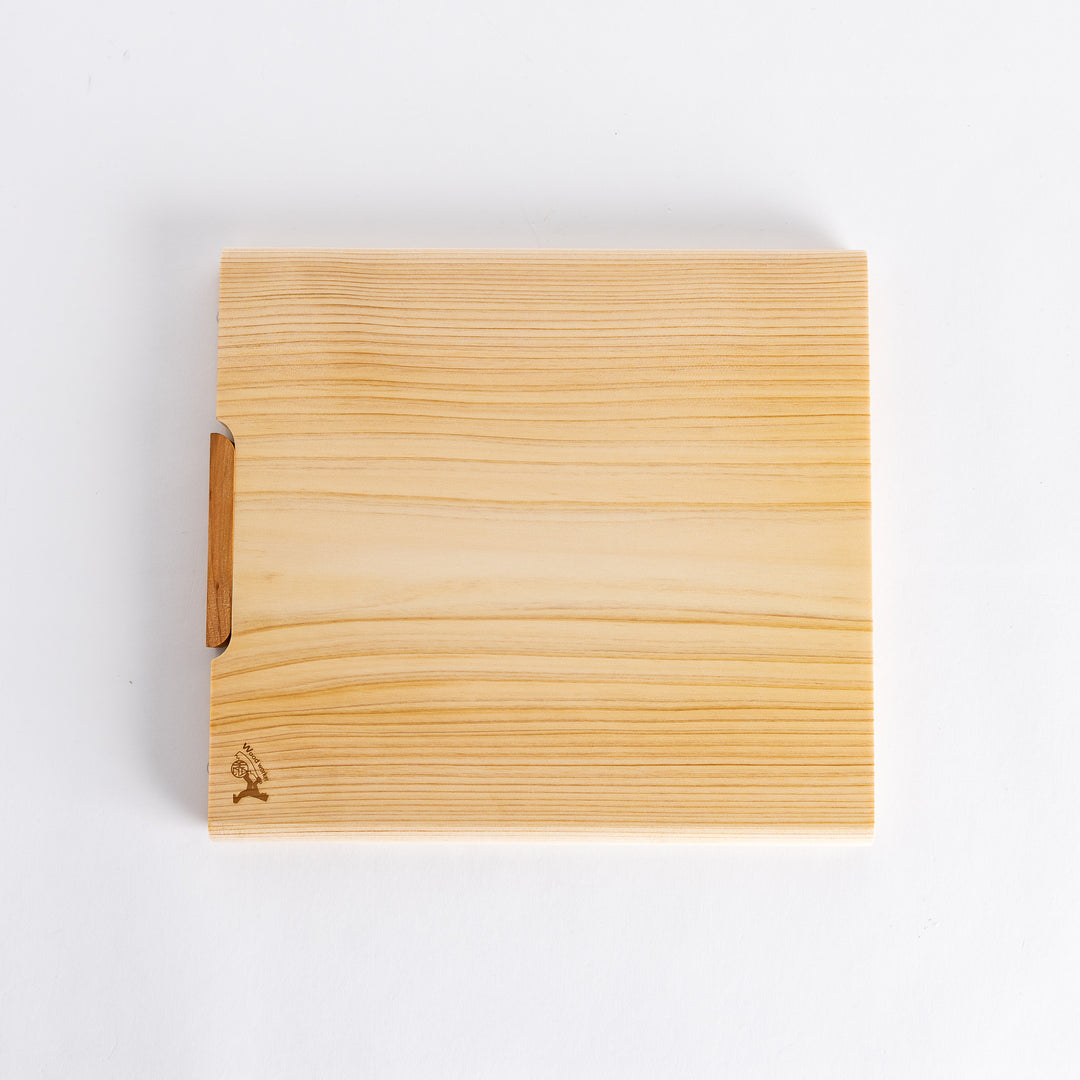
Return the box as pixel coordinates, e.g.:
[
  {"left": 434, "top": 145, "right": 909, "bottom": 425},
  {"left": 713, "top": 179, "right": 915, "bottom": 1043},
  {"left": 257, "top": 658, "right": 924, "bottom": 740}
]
[{"left": 210, "top": 251, "right": 874, "bottom": 837}]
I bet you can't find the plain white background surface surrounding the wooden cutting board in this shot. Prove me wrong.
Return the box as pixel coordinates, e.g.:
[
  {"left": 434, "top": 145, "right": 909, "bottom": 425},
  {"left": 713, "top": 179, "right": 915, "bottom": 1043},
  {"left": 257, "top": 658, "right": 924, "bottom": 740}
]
[{"left": 0, "top": 0, "right": 1080, "bottom": 1080}]
